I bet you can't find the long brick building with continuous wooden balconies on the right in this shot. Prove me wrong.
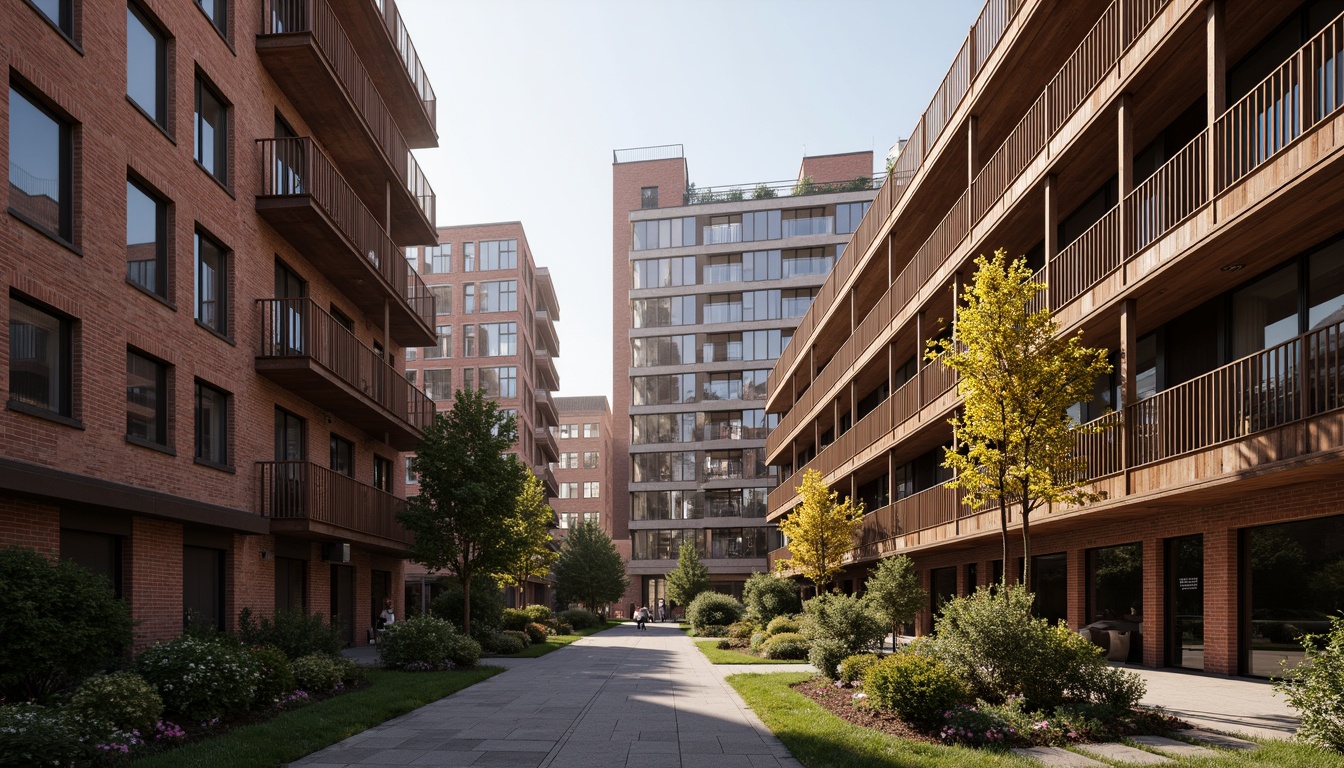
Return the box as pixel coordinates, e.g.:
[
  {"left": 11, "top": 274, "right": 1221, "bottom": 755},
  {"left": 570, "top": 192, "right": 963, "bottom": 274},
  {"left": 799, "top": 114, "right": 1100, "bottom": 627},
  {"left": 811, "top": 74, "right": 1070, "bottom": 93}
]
[{"left": 766, "top": 0, "right": 1344, "bottom": 675}]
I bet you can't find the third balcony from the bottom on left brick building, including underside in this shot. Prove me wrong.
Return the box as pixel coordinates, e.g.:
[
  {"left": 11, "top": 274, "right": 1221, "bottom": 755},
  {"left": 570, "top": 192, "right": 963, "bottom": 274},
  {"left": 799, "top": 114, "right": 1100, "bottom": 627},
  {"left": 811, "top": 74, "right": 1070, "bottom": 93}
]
[{"left": 257, "top": 137, "right": 438, "bottom": 347}]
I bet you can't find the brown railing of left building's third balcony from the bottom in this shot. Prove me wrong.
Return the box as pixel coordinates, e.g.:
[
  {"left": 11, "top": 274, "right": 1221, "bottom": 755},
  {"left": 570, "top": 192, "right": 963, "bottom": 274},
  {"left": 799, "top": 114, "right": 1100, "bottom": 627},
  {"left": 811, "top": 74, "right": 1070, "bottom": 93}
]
[{"left": 257, "top": 137, "right": 434, "bottom": 328}]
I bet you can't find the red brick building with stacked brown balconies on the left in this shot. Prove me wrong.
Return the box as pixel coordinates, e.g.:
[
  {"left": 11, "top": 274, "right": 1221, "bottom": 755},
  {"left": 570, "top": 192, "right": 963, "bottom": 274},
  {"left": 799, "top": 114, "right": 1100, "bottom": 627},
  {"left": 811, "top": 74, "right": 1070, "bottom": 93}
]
[{"left": 0, "top": 0, "right": 437, "bottom": 644}]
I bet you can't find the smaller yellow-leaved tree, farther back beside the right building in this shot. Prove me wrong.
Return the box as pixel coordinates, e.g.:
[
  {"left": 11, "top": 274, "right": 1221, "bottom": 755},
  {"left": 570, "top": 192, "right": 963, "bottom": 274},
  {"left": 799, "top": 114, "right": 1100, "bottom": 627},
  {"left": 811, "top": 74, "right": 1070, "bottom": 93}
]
[{"left": 778, "top": 469, "right": 863, "bottom": 594}]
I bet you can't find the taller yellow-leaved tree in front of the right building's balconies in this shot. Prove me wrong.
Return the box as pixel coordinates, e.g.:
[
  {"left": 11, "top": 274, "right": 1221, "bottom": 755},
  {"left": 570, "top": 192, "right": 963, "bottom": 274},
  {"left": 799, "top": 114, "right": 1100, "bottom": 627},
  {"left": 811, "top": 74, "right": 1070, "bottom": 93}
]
[{"left": 929, "top": 249, "right": 1110, "bottom": 584}]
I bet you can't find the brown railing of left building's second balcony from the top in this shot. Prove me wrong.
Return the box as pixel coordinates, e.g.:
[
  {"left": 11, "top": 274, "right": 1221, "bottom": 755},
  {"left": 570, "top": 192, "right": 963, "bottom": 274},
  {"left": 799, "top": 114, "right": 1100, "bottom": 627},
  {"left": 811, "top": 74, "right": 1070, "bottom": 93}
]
[{"left": 261, "top": 0, "right": 435, "bottom": 226}]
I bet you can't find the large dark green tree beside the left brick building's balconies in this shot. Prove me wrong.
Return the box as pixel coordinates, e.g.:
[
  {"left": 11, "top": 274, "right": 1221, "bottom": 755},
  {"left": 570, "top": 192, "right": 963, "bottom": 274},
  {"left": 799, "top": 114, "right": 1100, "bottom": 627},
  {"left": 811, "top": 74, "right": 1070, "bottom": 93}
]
[{"left": 396, "top": 390, "right": 527, "bottom": 632}]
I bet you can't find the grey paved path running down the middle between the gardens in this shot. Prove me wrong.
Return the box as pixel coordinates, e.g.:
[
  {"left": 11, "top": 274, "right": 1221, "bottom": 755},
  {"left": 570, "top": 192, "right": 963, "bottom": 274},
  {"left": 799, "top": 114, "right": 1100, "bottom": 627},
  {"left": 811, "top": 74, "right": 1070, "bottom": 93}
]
[{"left": 307, "top": 624, "right": 801, "bottom": 768}]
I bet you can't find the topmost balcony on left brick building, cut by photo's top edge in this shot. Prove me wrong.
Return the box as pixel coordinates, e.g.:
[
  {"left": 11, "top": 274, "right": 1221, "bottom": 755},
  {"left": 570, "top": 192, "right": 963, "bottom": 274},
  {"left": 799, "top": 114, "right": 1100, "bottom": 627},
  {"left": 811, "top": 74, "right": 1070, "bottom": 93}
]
[{"left": 321, "top": 0, "right": 438, "bottom": 147}]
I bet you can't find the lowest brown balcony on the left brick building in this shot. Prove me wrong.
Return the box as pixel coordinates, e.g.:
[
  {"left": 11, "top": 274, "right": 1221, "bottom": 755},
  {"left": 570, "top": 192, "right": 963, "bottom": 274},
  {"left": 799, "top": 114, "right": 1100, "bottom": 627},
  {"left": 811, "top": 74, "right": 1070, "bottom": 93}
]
[{"left": 257, "top": 461, "right": 413, "bottom": 557}]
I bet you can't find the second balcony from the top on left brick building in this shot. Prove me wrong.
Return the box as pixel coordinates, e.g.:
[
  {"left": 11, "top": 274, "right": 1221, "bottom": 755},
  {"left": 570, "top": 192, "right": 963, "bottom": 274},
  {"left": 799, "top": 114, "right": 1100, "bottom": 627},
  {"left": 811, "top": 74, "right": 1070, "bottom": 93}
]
[{"left": 257, "top": 0, "right": 437, "bottom": 245}]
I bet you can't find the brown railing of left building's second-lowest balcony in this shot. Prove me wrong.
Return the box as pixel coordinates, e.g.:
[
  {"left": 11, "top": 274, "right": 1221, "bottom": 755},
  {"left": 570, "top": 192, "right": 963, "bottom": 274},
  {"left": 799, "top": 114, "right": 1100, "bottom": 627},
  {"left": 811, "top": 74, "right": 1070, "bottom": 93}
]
[{"left": 257, "top": 299, "right": 434, "bottom": 430}]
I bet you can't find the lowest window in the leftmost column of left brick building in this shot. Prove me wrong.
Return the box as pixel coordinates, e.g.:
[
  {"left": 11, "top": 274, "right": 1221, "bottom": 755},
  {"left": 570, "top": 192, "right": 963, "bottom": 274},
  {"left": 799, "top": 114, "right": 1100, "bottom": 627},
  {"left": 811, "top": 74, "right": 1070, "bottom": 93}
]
[{"left": 9, "top": 297, "right": 73, "bottom": 416}]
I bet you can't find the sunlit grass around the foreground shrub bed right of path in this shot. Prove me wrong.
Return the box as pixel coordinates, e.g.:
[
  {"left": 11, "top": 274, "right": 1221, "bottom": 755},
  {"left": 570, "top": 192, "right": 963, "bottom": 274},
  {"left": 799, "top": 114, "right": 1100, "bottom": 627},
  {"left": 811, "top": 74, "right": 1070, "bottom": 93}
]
[{"left": 728, "top": 673, "right": 1344, "bottom": 768}]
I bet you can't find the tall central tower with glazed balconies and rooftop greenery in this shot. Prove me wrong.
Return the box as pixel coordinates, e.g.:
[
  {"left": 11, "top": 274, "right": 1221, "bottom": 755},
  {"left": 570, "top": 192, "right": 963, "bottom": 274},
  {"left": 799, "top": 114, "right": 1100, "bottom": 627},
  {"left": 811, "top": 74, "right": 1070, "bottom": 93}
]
[{"left": 612, "top": 145, "right": 878, "bottom": 607}]
